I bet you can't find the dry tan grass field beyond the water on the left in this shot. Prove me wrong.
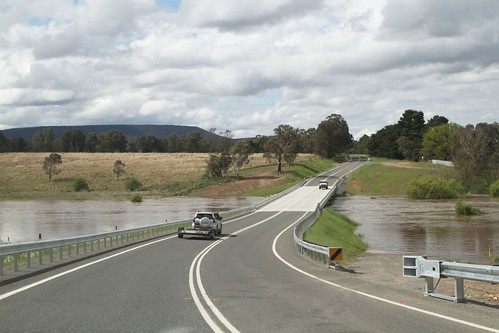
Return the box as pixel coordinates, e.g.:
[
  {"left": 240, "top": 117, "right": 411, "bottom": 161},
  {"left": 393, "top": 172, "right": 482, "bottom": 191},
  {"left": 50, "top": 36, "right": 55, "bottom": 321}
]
[{"left": 0, "top": 153, "right": 309, "bottom": 199}]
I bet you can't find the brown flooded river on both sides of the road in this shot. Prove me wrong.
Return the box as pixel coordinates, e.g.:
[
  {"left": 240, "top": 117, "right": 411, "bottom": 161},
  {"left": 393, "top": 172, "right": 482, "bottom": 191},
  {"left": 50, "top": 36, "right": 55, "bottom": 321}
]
[{"left": 0, "top": 196, "right": 499, "bottom": 263}]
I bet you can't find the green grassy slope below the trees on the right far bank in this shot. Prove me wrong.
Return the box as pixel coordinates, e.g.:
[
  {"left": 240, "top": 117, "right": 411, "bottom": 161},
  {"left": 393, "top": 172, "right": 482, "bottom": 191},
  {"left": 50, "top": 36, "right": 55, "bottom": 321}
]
[{"left": 345, "top": 159, "right": 456, "bottom": 196}]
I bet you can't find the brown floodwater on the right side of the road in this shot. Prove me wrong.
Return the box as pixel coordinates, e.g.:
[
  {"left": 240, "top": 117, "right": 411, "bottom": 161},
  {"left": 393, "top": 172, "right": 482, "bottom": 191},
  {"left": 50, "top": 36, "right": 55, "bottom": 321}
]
[{"left": 331, "top": 196, "right": 499, "bottom": 264}]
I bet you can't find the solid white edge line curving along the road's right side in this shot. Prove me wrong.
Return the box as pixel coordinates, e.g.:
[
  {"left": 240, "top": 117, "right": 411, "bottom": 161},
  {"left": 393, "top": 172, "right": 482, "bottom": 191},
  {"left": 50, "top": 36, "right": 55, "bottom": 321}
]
[{"left": 272, "top": 218, "right": 499, "bottom": 333}]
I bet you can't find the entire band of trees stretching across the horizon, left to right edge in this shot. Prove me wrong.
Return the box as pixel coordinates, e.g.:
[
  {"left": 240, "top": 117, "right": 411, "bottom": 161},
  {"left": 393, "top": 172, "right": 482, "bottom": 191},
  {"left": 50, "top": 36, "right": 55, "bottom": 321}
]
[{"left": 0, "top": 110, "right": 499, "bottom": 192}]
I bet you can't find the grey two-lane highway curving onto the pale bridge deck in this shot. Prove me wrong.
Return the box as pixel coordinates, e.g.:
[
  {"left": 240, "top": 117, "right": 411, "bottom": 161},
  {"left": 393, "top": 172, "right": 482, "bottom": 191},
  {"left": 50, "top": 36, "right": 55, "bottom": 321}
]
[{"left": 0, "top": 163, "right": 499, "bottom": 332}]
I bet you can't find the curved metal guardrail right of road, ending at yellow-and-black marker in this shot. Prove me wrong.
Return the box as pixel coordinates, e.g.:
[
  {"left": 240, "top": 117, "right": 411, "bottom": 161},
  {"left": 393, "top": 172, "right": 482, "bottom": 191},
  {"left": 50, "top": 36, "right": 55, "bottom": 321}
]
[{"left": 294, "top": 176, "right": 347, "bottom": 266}]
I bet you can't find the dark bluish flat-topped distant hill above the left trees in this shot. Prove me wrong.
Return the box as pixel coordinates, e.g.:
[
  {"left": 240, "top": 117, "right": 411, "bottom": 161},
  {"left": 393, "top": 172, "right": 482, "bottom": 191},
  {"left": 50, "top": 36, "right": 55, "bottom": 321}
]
[{"left": 1, "top": 125, "right": 214, "bottom": 140}]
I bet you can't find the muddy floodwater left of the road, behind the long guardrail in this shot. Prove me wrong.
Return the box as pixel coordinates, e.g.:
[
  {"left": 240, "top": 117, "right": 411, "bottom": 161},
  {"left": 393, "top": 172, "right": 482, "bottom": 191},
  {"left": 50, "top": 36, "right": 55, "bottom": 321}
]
[{"left": 0, "top": 197, "right": 262, "bottom": 243}]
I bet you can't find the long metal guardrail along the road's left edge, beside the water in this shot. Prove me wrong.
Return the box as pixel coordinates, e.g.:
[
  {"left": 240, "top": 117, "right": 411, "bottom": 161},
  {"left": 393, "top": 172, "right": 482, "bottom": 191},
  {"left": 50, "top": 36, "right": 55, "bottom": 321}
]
[{"left": 0, "top": 181, "right": 304, "bottom": 276}]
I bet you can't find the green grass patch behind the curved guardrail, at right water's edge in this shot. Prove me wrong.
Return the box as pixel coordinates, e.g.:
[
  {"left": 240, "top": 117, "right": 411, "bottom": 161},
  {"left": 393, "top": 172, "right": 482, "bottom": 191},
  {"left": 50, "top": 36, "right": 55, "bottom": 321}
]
[{"left": 303, "top": 208, "right": 367, "bottom": 263}]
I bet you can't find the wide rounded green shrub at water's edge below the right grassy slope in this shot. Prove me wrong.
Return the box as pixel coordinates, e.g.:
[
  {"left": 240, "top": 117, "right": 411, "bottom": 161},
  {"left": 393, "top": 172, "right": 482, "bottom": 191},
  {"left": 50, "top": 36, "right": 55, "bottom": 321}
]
[{"left": 406, "top": 176, "right": 463, "bottom": 199}]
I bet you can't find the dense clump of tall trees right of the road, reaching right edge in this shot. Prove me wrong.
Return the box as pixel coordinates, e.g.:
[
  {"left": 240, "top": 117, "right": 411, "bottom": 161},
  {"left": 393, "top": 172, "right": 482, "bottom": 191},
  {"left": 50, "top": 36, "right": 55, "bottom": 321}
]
[{"left": 354, "top": 110, "right": 499, "bottom": 192}]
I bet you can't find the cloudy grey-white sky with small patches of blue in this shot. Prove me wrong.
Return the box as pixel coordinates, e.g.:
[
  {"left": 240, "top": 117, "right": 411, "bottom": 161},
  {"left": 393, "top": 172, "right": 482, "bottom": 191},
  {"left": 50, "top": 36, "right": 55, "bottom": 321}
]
[{"left": 0, "top": 0, "right": 499, "bottom": 139}]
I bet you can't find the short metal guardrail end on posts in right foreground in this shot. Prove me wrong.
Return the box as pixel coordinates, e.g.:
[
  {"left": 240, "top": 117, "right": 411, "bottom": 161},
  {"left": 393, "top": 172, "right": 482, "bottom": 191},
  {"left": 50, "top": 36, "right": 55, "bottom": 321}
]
[{"left": 403, "top": 256, "right": 499, "bottom": 303}]
